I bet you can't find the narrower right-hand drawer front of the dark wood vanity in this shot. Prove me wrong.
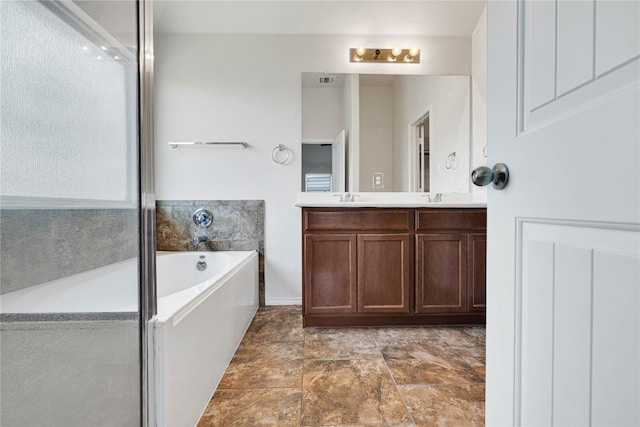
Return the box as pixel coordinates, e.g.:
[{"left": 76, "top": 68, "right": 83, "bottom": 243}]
[{"left": 416, "top": 209, "right": 487, "bottom": 232}]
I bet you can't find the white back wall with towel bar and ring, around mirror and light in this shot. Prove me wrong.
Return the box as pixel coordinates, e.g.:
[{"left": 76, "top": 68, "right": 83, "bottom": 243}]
[{"left": 154, "top": 34, "right": 471, "bottom": 304}]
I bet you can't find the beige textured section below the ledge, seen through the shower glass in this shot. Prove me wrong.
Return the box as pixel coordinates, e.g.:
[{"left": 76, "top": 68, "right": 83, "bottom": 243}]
[{"left": 0, "top": 318, "right": 140, "bottom": 426}]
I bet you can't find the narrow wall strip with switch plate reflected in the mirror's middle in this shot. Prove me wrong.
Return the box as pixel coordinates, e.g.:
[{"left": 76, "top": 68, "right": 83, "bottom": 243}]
[{"left": 360, "top": 86, "right": 393, "bottom": 191}]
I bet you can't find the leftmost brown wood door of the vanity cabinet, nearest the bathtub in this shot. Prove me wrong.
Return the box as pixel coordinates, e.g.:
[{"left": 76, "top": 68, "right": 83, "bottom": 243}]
[{"left": 302, "top": 234, "right": 357, "bottom": 314}]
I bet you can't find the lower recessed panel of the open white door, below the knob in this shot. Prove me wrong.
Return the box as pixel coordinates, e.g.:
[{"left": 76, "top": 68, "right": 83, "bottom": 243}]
[{"left": 516, "top": 220, "right": 640, "bottom": 426}]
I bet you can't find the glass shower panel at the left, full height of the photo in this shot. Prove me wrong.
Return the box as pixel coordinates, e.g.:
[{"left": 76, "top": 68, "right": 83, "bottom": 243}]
[{"left": 0, "top": 0, "right": 141, "bottom": 426}]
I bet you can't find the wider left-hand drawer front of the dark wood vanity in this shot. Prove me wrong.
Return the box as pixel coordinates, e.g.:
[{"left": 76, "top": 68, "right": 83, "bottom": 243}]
[{"left": 302, "top": 208, "right": 414, "bottom": 232}]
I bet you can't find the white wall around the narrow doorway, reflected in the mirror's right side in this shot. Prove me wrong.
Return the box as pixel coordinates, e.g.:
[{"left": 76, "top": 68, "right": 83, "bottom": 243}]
[{"left": 393, "top": 76, "right": 470, "bottom": 193}]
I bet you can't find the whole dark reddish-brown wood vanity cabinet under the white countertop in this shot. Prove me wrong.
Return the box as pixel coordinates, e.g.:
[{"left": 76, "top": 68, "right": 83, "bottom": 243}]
[{"left": 302, "top": 208, "right": 486, "bottom": 326}]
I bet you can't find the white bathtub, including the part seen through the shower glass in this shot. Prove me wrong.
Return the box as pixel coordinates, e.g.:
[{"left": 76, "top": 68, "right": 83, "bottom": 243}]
[{"left": 0, "top": 251, "right": 258, "bottom": 427}]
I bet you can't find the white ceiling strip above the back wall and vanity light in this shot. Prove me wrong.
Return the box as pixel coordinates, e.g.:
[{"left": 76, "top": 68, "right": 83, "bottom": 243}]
[{"left": 153, "top": 0, "right": 485, "bottom": 37}]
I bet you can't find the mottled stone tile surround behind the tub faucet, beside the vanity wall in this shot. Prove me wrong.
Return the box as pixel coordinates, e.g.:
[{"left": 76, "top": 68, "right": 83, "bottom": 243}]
[{"left": 156, "top": 200, "right": 265, "bottom": 306}]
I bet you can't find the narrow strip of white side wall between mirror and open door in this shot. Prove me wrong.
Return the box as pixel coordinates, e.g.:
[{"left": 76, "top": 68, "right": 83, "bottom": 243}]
[{"left": 471, "top": 7, "right": 487, "bottom": 194}]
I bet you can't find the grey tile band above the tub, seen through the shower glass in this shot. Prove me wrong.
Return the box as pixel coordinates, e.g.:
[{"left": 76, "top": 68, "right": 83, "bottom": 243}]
[{"left": 0, "top": 209, "right": 139, "bottom": 294}]
